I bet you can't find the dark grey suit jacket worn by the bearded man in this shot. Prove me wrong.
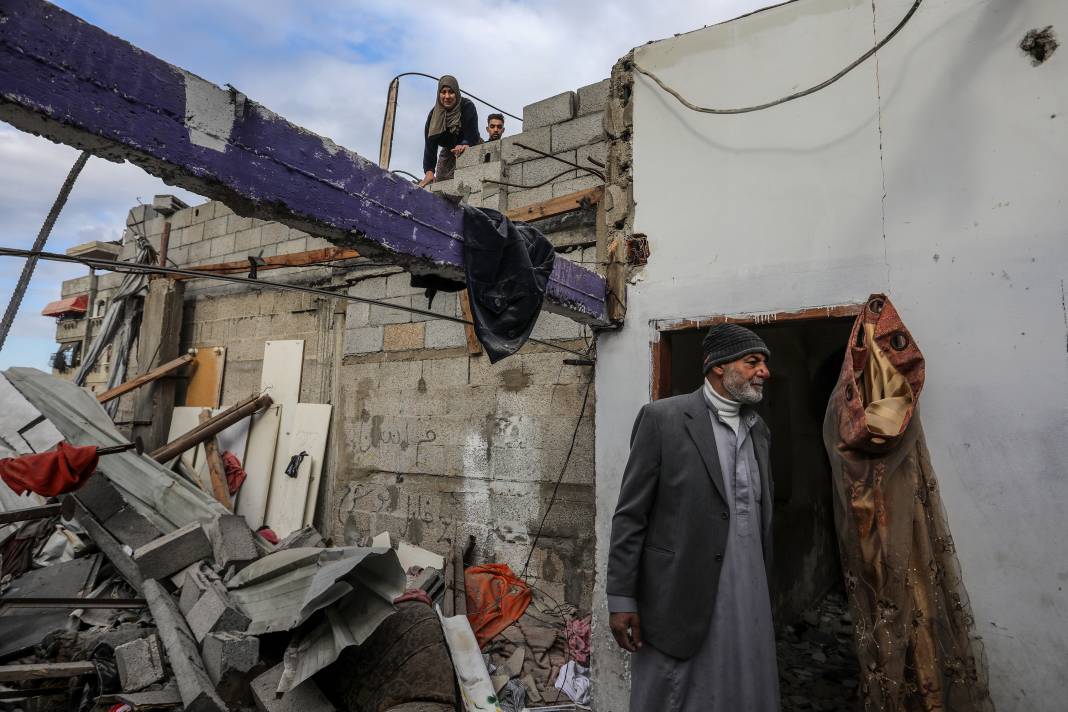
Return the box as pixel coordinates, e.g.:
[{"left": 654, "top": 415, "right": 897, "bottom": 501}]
[{"left": 608, "top": 389, "right": 774, "bottom": 659}]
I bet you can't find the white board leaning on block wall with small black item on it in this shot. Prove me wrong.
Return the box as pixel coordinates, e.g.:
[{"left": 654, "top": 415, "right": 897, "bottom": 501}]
[{"left": 266, "top": 404, "right": 333, "bottom": 537}]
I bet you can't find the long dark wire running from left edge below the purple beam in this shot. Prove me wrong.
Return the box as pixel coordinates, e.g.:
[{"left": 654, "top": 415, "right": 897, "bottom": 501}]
[{"left": 0, "top": 248, "right": 588, "bottom": 359}]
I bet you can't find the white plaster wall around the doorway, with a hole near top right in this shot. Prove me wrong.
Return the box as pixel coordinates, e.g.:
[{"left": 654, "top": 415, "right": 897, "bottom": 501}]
[{"left": 594, "top": 0, "right": 1068, "bottom": 712}]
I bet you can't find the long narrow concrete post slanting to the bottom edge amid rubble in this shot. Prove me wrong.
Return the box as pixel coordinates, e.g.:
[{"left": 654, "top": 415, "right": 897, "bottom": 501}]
[{"left": 144, "top": 580, "right": 226, "bottom": 712}]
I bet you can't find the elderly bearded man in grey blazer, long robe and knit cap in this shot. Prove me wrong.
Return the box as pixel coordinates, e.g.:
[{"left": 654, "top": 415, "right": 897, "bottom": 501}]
[{"left": 608, "top": 323, "right": 779, "bottom": 712}]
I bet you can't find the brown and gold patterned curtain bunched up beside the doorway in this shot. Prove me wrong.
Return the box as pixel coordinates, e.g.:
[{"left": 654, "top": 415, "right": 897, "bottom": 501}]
[{"left": 823, "top": 295, "right": 993, "bottom": 712}]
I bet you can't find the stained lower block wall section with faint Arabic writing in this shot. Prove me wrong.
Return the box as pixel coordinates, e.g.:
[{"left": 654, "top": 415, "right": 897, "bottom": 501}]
[{"left": 325, "top": 345, "right": 594, "bottom": 610}]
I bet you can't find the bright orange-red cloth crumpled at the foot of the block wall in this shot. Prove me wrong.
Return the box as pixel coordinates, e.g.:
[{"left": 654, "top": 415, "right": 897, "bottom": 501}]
[{"left": 464, "top": 564, "right": 531, "bottom": 648}]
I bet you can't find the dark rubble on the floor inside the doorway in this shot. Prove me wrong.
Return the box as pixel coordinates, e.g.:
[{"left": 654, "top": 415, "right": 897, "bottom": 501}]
[{"left": 778, "top": 590, "right": 863, "bottom": 712}]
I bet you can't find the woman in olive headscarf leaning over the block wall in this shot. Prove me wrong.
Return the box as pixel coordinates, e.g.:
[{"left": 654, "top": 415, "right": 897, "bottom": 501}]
[{"left": 419, "top": 75, "right": 482, "bottom": 187}]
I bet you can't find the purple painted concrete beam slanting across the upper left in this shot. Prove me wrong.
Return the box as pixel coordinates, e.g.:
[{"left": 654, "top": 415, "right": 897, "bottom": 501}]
[{"left": 0, "top": 0, "right": 608, "bottom": 325}]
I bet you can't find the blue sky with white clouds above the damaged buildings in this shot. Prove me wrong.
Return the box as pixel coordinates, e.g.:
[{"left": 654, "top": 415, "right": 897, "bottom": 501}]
[{"left": 0, "top": 0, "right": 774, "bottom": 368}]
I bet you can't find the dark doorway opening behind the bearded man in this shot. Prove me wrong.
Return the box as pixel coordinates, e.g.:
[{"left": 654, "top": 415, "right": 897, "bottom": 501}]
[{"left": 653, "top": 305, "right": 861, "bottom": 712}]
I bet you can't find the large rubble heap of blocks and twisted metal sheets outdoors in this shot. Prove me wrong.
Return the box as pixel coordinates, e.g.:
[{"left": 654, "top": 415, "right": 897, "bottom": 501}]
[{"left": 0, "top": 368, "right": 576, "bottom": 712}]
